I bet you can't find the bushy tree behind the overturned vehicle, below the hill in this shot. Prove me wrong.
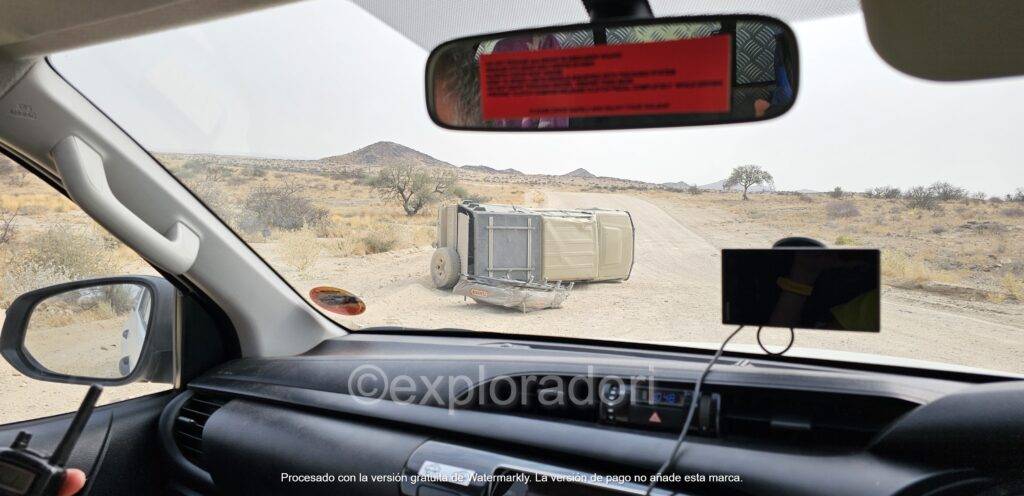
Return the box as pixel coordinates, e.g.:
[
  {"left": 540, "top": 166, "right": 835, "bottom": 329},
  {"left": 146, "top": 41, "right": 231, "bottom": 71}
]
[{"left": 370, "top": 164, "right": 458, "bottom": 216}]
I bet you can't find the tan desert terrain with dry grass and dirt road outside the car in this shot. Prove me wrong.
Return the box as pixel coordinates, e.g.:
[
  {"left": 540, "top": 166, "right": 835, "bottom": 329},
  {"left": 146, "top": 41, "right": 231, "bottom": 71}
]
[{"left": 0, "top": 142, "right": 1024, "bottom": 423}]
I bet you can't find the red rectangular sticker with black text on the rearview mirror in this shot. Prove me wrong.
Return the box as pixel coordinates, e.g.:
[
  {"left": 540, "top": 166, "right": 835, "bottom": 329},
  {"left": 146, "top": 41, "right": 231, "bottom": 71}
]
[{"left": 480, "top": 35, "right": 732, "bottom": 120}]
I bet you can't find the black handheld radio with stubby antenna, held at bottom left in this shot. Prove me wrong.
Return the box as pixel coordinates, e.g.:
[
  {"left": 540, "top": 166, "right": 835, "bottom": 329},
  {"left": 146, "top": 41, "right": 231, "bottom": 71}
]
[{"left": 0, "top": 384, "right": 103, "bottom": 496}]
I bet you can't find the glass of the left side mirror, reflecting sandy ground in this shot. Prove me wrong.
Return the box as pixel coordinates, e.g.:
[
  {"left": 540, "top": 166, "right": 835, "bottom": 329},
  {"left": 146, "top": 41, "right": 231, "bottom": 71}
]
[{"left": 25, "top": 284, "right": 153, "bottom": 379}]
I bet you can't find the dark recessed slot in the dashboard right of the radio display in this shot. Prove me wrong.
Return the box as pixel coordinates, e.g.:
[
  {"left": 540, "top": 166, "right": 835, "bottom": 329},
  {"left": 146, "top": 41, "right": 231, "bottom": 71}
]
[{"left": 715, "top": 387, "right": 919, "bottom": 450}]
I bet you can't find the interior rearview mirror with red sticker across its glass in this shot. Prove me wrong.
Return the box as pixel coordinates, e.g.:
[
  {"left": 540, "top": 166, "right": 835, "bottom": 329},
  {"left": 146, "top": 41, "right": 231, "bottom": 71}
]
[{"left": 426, "top": 15, "right": 798, "bottom": 131}]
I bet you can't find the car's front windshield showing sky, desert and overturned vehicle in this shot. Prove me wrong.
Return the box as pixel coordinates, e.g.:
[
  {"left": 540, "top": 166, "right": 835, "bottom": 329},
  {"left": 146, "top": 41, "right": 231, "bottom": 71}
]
[{"left": 50, "top": 1, "right": 1024, "bottom": 372}]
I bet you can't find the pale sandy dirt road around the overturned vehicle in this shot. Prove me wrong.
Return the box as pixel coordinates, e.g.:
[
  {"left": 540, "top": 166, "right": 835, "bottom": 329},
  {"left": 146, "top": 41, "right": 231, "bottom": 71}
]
[{"left": 292, "top": 192, "right": 1024, "bottom": 372}]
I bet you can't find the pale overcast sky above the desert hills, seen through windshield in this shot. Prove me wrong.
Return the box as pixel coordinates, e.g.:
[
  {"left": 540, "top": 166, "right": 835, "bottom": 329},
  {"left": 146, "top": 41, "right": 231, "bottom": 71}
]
[{"left": 52, "top": 1, "right": 1024, "bottom": 195}]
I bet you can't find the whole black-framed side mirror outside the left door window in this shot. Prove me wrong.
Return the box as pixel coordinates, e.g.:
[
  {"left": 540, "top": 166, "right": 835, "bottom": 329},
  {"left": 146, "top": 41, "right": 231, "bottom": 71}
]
[{"left": 0, "top": 276, "right": 177, "bottom": 385}]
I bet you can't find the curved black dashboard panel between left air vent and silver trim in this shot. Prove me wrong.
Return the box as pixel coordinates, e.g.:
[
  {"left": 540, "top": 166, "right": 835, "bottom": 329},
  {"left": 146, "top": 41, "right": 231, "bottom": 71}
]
[{"left": 203, "top": 400, "right": 427, "bottom": 495}]
